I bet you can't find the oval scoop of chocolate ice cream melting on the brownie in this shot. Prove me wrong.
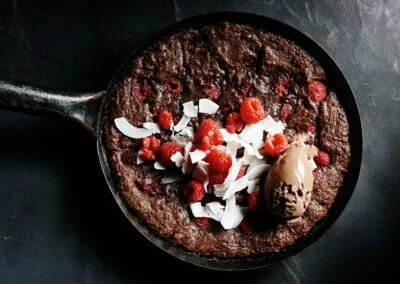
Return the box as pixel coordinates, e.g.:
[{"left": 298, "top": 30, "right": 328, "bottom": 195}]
[{"left": 264, "top": 135, "right": 317, "bottom": 219}]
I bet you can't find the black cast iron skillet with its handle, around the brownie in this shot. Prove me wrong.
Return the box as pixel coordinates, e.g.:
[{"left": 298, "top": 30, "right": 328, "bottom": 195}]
[{"left": 0, "top": 12, "right": 362, "bottom": 270}]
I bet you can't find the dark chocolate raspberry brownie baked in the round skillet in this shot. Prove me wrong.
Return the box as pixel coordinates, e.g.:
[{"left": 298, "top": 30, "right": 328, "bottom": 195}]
[{"left": 103, "top": 23, "right": 350, "bottom": 258}]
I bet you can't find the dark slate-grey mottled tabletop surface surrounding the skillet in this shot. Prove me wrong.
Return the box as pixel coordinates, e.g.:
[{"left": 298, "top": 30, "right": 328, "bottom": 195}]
[{"left": 0, "top": 0, "right": 400, "bottom": 283}]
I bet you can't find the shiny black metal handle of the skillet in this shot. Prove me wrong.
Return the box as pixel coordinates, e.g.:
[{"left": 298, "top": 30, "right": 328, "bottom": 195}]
[{"left": 0, "top": 81, "right": 106, "bottom": 136}]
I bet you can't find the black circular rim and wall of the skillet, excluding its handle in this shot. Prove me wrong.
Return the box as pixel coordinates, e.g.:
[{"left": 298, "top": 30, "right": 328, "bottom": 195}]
[{"left": 96, "top": 12, "right": 362, "bottom": 270}]
